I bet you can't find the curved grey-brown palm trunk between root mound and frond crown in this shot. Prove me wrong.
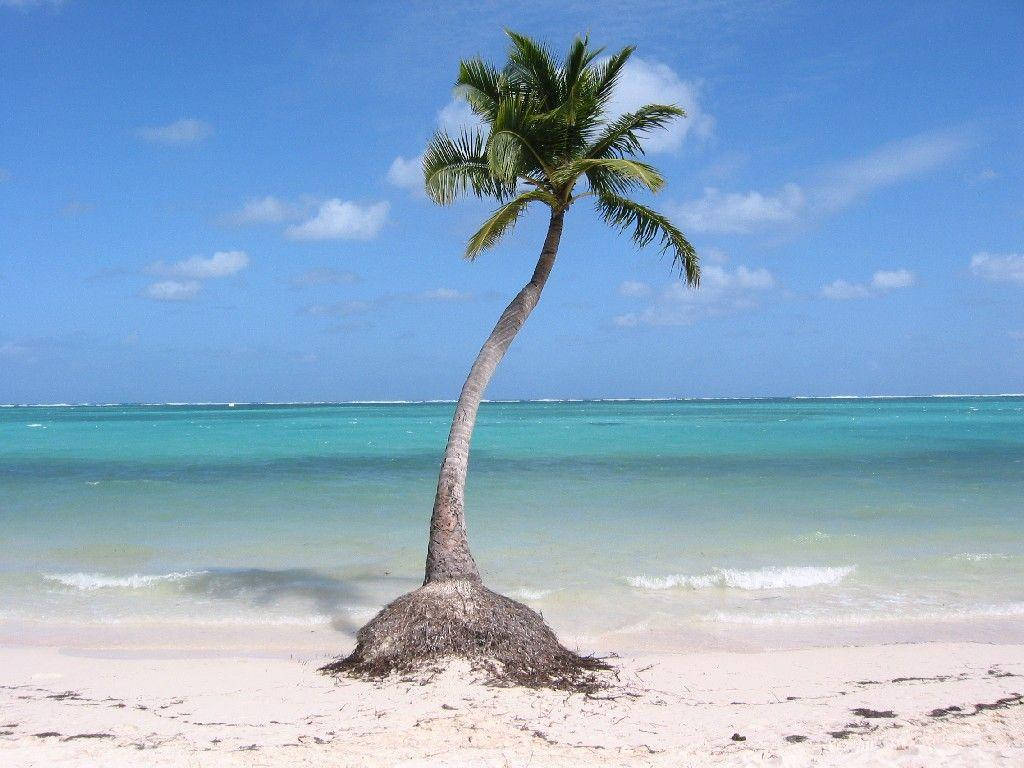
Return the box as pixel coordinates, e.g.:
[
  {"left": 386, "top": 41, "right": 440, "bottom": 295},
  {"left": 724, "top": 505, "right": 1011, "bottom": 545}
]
[{"left": 423, "top": 211, "right": 565, "bottom": 584}]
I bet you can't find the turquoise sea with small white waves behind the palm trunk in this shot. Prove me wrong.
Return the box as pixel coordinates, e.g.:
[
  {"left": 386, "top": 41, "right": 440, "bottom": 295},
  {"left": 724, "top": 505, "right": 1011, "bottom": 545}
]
[{"left": 0, "top": 397, "right": 1024, "bottom": 644}]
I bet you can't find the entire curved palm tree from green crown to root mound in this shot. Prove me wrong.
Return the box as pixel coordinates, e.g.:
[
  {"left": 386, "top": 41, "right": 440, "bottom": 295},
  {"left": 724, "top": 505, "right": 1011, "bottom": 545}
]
[{"left": 325, "top": 32, "right": 700, "bottom": 687}]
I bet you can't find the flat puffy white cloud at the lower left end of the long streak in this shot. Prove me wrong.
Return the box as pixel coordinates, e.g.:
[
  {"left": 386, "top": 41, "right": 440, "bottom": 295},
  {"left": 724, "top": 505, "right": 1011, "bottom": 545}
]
[{"left": 677, "top": 184, "right": 807, "bottom": 232}]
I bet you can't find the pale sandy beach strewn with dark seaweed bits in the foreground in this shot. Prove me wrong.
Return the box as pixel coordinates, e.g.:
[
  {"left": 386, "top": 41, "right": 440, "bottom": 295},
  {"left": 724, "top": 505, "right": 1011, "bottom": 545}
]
[{"left": 0, "top": 643, "right": 1024, "bottom": 768}]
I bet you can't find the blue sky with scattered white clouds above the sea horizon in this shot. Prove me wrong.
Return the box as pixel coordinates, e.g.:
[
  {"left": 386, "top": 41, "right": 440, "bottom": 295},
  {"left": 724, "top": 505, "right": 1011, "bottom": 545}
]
[{"left": 0, "top": 0, "right": 1024, "bottom": 403}]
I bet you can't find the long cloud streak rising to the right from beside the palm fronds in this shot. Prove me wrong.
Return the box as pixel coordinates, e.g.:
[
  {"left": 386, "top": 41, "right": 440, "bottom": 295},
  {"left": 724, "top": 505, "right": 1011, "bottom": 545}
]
[{"left": 675, "top": 133, "right": 966, "bottom": 233}]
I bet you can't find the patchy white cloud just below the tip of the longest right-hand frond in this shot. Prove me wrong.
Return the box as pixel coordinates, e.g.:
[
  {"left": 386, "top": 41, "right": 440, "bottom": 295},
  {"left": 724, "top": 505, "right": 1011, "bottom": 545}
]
[{"left": 612, "top": 264, "right": 776, "bottom": 328}]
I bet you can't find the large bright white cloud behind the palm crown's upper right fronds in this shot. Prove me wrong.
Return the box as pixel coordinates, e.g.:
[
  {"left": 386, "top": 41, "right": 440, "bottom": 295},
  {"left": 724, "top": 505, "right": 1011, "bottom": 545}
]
[{"left": 608, "top": 56, "right": 715, "bottom": 153}]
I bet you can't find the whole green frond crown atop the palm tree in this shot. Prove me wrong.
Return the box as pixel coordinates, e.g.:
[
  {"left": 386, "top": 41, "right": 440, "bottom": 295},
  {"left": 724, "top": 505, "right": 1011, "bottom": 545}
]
[{"left": 423, "top": 31, "right": 700, "bottom": 286}]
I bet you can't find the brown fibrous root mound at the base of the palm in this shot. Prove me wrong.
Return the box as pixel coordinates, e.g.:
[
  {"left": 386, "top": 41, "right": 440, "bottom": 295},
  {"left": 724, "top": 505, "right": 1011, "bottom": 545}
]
[{"left": 321, "top": 581, "right": 609, "bottom": 692}]
